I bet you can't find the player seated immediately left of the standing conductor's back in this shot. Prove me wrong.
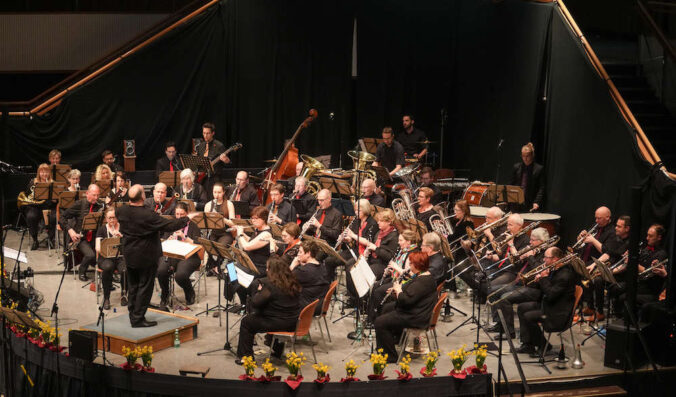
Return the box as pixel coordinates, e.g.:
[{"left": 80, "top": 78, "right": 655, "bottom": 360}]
[{"left": 96, "top": 208, "right": 127, "bottom": 310}]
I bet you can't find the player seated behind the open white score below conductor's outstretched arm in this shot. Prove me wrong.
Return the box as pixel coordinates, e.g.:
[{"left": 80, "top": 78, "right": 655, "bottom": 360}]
[{"left": 157, "top": 203, "right": 202, "bottom": 309}]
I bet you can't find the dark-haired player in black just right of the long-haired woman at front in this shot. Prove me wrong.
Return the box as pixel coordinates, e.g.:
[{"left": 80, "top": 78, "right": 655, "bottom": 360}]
[{"left": 289, "top": 241, "right": 329, "bottom": 315}]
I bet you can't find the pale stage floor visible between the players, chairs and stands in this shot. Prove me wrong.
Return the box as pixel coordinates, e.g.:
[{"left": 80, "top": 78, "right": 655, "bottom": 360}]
[{"left": 1, "top": 231, "right": 660, "bottom": 382}]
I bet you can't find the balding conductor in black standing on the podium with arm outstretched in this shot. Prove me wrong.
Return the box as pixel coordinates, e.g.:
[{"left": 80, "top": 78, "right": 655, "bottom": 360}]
[{"left": 116, "top": 185, "right": 190, "bottom": 328}]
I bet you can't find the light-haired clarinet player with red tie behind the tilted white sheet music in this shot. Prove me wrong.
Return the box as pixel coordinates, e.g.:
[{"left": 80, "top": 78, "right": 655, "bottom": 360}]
[{"left": 326, "top": 199, "right": 378, "bottom": 280}]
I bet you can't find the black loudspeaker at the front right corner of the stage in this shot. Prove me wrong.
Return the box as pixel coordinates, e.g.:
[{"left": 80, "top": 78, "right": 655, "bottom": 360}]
[{"left": 603, "top": 322, "right": 647, "bottom": 370}]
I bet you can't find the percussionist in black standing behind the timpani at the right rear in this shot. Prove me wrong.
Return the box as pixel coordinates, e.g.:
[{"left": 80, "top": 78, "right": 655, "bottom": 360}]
[{"left": 512, "top": 142, "right": 545, "bottom": 212}]
